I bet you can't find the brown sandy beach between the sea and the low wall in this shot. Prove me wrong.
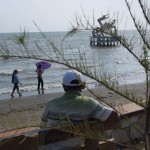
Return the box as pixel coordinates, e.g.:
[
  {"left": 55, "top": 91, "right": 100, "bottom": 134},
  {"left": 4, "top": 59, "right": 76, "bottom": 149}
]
[{"left": 0, "top": 83, "right": 146, "bottom": 133}]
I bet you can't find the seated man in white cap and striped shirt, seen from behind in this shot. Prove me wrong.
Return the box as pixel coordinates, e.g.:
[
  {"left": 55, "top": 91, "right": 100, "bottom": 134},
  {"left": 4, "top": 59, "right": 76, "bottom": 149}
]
[{"left": 41, "top": 70, "right": 119, "bottom": 129}]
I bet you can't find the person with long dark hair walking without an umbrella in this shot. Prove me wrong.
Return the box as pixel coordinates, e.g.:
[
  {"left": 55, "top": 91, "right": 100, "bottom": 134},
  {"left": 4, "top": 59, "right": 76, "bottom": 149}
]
[{"left": 11, "top": 70, "right": 22, "bottom": 97}]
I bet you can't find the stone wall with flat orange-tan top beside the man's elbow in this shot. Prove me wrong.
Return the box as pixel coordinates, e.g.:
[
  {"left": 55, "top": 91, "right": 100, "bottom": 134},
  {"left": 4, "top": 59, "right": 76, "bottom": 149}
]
[{"left": 112, "top": 103, "right": 145, "bottom": 143}]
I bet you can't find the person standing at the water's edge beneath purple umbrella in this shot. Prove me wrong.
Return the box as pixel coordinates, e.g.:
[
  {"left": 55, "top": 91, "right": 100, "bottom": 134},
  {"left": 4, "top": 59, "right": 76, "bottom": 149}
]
[{"left": 36, "top": 65, "right": 44, "bottom": 90}]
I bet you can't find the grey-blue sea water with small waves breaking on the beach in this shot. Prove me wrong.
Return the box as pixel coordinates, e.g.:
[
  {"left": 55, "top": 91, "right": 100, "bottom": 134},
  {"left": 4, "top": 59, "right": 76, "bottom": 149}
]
[{"left": 0, "top": 31, "right": 145, "bottom": 100}]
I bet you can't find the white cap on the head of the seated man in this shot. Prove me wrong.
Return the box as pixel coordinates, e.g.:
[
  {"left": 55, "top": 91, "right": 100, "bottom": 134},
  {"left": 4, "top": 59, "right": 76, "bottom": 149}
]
[{"left": 62, "top": 70, "right": 82, "bottom": 86}]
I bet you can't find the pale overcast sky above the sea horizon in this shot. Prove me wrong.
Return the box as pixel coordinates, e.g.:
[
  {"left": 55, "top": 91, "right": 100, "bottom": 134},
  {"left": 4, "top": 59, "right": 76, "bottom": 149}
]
[{"left": 0, "top": 0, "right": 144, "bottom": 33}]
